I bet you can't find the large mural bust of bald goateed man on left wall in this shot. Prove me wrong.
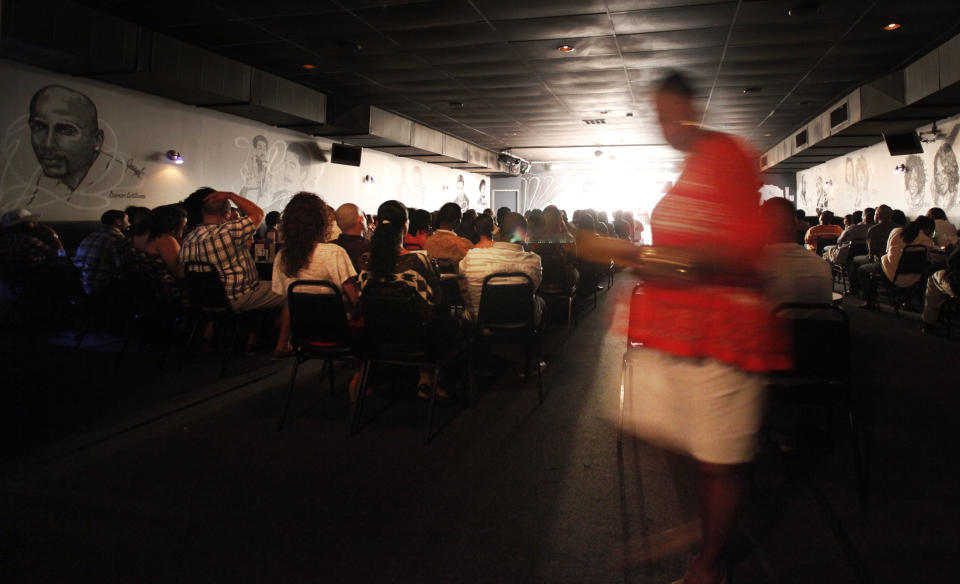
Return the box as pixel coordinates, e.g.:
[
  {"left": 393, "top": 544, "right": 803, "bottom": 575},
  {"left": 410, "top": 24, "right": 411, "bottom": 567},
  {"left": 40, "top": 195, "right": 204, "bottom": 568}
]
[{"left": 0, "top": 85, "right": 146, "bottom": 209}]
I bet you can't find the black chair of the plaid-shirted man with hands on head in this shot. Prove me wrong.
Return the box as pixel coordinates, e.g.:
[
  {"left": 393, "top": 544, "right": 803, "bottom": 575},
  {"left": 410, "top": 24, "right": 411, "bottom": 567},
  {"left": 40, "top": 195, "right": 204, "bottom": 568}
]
[{"left": 183, "top": 262, "right": 258, "bottom": 377}]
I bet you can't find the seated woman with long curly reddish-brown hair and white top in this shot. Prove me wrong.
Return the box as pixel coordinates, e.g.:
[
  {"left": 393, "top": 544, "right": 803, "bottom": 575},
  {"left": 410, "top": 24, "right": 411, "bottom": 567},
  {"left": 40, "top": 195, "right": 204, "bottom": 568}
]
[{"left": 271, "top": 193, "right": 359, "bottom": 356}]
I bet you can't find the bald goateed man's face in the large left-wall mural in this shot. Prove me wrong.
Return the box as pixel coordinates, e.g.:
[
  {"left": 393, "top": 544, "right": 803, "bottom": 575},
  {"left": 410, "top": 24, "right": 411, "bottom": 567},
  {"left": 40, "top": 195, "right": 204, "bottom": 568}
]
[{"left": 29, "top": 85, "right": 103, "bottom": 189}]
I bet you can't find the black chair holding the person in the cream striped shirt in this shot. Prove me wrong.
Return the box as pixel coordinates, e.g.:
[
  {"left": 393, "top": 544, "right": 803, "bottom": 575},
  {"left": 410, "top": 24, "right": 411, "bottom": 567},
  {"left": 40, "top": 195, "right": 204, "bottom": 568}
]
[{"left": 470, "top": 272, "right": 546, "bottom": 403}]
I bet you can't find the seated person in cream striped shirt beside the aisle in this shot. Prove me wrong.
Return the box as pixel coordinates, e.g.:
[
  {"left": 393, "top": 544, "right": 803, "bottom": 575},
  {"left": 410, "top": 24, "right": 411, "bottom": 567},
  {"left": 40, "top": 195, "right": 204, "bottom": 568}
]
[{"left": 460, "top": 213, "right": 544, "bottom": 323}]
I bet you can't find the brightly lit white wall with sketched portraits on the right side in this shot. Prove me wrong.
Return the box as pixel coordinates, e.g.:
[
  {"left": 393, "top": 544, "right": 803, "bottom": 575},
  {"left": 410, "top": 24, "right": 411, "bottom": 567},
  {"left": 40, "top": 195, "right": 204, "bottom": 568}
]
[{"left": 797, "top": 116, "right": 960, "bottom": 223}]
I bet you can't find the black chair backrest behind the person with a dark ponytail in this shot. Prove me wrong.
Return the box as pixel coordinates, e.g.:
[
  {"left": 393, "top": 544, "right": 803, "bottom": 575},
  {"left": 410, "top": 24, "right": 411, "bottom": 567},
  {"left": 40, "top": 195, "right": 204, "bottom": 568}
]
[{"left": 360, "top": 282, "right": 427, "bottom": 353}]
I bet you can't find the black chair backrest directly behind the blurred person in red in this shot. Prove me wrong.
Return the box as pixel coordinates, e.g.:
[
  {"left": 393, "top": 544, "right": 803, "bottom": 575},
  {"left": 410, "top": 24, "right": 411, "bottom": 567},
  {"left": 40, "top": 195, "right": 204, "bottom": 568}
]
[{"left": 773, "top": 302, "right": 850, "bottom": 381}]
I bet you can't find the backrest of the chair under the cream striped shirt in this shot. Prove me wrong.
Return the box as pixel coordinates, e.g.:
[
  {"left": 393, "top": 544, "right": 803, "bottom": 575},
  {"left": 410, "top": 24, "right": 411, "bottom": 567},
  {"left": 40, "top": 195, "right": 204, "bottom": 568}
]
[{"left": 477, "top": 272, "right": 534, "bottom": 331}]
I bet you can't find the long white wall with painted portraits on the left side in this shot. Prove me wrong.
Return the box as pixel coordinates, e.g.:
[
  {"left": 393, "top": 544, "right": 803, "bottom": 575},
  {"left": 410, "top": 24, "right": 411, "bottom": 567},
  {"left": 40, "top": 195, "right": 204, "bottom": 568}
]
[{"left": 0, "top": 59, "right": 489, "bottom": 221}]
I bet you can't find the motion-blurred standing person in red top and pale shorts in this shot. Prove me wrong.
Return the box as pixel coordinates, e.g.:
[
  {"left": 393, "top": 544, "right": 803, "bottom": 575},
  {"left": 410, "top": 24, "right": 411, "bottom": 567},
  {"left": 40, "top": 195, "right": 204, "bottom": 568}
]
[{"left": 629, "top": 73, "right": 789, "bottom": 584}]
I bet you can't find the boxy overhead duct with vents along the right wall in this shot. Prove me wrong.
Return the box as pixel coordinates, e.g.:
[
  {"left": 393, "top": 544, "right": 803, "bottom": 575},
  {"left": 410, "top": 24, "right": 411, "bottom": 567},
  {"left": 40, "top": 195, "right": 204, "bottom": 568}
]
[{"left": 760, "top": 31, "right": 960, "bottom": 172}]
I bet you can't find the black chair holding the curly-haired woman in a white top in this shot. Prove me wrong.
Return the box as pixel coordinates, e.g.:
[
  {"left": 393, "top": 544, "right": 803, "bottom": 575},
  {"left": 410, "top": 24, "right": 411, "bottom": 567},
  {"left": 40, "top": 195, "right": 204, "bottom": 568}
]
[{"left": 277, "top": 280, "right": 356, "bottom": 430}]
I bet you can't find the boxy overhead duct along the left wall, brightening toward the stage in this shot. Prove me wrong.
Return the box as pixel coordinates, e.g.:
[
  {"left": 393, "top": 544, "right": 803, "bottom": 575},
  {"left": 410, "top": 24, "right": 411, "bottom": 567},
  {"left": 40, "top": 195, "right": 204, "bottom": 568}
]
[{"left": 312, "top": 105, "right": 510, "bottom": 175}]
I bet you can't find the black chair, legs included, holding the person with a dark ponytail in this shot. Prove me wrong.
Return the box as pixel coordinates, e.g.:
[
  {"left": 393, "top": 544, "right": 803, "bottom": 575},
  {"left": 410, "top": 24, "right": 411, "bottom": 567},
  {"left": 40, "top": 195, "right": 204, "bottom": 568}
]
[{"left": 350, "top": 282, "right": 454, "bottom": 444}]
